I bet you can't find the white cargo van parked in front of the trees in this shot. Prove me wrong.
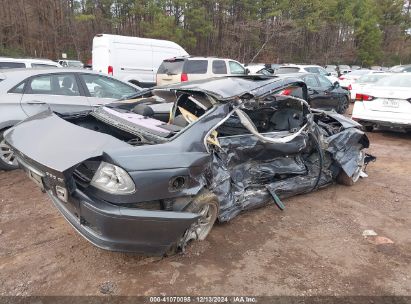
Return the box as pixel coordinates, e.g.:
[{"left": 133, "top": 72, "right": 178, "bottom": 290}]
[{"left": 92, "top": 34, "right": 188, "bottom": 87}]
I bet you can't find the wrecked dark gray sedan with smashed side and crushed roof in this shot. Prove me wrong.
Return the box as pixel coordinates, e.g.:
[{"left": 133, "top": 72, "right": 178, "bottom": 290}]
[{"left": 5, "top": 77, "right": 369, "bottom": 255}]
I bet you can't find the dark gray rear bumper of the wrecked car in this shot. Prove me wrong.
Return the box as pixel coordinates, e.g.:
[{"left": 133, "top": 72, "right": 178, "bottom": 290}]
[{"left": 47, "top": 189, "right": 198, "bottom": 255}]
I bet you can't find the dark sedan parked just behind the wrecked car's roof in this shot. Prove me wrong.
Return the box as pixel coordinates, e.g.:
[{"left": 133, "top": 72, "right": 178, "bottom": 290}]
[{"left": 280, "top": 73, "right": 350, "bottom": 114}]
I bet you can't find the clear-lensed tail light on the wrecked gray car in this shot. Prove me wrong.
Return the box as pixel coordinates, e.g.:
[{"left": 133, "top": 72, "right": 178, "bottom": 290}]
[{"left": 90, "top": 162, "right": 136, "bottom": 194}]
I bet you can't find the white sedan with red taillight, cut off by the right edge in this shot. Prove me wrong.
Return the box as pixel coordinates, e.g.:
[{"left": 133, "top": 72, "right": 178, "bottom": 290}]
[{"left": 352, "top": 74, "right": 411, "bottom": 131}]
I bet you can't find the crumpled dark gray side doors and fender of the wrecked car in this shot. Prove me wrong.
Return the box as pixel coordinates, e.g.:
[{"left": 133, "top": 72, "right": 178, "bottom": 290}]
[{"left": 210, "top": 125, "right": 364, "bottom": 222}]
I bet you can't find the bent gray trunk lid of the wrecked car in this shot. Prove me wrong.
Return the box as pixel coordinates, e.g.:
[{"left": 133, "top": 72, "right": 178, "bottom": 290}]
[{"left": 5, "top": 111, "right": 130, "bottom": 172}]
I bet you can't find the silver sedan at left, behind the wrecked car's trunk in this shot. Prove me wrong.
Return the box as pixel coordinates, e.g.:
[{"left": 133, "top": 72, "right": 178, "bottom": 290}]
[{"left": 0, "top": 68, "right": 141, "bottom": 170}]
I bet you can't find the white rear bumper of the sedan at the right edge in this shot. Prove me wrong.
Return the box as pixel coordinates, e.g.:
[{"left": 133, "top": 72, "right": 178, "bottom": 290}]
[{"left": 352, "top": 102, "right": 411, "bottom": 129}]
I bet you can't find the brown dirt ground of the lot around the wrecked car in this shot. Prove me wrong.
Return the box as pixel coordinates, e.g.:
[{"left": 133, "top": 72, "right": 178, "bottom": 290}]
[{"left": 0, "top": 105, "right": 411, "bottom": 295}]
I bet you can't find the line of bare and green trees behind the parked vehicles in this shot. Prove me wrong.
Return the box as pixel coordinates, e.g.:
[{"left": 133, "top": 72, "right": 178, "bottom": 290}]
[{"left": 0, "top": 0, "right": 411, "bottom": 66}]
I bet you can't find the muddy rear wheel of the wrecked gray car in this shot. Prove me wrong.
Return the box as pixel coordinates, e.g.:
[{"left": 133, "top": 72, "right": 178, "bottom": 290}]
[{"left": 178, "top": 190, "right": 219, "bottom": 250}]
